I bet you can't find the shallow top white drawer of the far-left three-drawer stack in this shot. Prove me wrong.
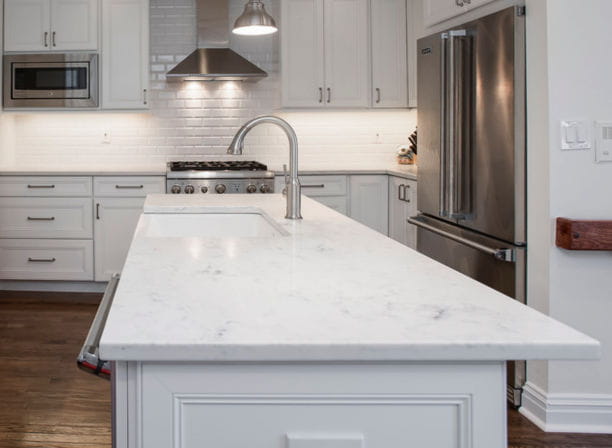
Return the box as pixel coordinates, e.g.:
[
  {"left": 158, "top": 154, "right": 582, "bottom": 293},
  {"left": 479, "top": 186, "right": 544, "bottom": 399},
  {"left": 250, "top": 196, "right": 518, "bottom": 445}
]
[{"left": 0, "top": 176, "right": 91, "bottom": 197}]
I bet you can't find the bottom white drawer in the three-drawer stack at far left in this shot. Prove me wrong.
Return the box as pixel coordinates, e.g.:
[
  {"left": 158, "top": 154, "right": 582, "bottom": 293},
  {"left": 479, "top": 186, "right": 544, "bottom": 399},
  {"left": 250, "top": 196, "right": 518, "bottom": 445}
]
[{"left": 0, "top": 239, "right": 93, "bottom": 281}]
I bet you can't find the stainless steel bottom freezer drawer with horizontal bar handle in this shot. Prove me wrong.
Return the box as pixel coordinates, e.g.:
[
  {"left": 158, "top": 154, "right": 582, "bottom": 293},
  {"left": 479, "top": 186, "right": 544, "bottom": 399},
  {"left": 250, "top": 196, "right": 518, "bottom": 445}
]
[{"left": 409, "top": 215, "right": 525, "bottom": 303}]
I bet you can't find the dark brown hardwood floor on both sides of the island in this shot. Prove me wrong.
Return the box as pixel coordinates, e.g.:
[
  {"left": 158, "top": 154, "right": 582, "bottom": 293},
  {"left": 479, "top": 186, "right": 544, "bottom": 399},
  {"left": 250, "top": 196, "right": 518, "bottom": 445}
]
[{"left": 0, "top": 292, "right": 612, "bottom": 448}]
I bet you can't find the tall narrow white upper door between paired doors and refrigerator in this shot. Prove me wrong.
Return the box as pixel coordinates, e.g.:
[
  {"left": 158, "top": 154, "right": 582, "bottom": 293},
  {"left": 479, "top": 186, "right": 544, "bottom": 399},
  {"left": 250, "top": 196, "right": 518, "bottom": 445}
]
[{"left": 371, "top": 0, "right": 408, "bottom": 107}]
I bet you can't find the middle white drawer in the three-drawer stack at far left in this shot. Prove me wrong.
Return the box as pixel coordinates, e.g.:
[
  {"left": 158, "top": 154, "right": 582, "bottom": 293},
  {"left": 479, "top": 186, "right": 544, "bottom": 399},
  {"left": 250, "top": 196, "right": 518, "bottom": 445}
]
[{"left": 0, "top": 198, "right": 93, "bottom": 239}]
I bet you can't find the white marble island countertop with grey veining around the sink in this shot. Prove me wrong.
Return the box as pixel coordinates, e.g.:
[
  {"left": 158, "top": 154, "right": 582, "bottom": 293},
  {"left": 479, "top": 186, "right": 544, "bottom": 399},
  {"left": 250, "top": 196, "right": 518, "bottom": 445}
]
[{"left": 100, "top": 195, "right": 600, "bottom": 361}]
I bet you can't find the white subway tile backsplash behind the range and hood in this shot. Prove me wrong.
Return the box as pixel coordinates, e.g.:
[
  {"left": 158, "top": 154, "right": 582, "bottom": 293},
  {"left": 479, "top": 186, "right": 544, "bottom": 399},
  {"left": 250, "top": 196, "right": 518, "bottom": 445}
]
[{"left": 0, "top": 0, "right": 416, "bottom": 167}]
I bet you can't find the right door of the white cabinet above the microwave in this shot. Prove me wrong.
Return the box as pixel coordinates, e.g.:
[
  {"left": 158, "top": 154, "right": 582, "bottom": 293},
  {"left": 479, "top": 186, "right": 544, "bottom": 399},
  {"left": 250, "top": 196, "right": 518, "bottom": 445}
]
[{"left": 51, "top": 0, "right": 98, "bottom": 50}]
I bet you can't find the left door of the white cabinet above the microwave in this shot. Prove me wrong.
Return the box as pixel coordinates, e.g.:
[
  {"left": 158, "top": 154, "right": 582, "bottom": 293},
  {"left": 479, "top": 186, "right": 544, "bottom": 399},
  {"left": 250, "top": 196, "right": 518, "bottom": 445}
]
[{"left": 4, "top": 0, "right": 51, "bottom": 51}]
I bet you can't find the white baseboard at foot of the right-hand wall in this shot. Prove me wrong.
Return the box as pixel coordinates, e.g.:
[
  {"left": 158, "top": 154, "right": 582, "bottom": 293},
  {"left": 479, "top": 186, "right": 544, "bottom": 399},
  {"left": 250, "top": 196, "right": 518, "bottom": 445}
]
[{"left": 519, "top": 382, "right": 612, "bottom": 434}]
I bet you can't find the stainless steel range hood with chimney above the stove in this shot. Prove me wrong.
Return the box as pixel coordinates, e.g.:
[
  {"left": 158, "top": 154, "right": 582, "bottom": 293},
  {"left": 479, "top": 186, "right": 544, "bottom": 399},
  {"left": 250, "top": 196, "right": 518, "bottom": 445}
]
[{"left": 166, "top": 0, "right": 268, "bottom": 82}]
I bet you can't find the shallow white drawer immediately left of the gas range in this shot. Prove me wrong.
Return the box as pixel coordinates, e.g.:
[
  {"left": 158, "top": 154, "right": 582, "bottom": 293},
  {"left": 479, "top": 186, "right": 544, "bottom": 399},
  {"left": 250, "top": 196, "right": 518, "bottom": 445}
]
[{"left": 94, "top": 176, "right": 166, "bottom": 198}]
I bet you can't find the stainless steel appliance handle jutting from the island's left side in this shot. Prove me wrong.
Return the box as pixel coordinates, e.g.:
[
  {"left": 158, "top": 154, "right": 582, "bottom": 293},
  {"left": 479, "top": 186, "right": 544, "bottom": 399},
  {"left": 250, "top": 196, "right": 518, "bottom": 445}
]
[{"left": 77, "top": 274, "right": 120, "bottom": 379}]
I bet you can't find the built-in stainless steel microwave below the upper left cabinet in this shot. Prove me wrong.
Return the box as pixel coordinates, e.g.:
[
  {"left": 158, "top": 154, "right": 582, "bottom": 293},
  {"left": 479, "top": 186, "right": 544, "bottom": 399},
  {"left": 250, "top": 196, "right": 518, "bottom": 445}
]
[{"left": 4, "top": 53, "right": 98, "bottom": 108}]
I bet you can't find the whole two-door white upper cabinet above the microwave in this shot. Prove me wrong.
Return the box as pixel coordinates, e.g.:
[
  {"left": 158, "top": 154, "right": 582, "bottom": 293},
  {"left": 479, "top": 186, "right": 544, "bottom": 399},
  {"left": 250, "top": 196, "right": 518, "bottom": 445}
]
[{"left": 4, "top": 0, "right": 98, "bottom": 51}]
